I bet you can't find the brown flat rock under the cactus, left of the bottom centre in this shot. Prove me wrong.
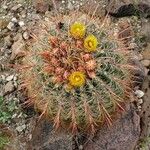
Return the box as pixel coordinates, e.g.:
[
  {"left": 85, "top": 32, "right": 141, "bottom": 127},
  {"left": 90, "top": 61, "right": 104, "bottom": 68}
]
[{"left": 27, "top": 120, "right": 72, "bottom": 150}]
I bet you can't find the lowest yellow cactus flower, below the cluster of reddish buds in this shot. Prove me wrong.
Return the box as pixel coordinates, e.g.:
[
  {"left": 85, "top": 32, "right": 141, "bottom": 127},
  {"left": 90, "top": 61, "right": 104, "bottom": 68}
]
[{"left": 69, "top": 71, "right": 85, "bottom": 87}]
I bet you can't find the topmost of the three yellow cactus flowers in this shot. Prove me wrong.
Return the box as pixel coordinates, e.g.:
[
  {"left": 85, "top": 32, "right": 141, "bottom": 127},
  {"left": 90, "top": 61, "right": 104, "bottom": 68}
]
[{"left": 70, "top": 22, "right": 86, "bottom": 39}]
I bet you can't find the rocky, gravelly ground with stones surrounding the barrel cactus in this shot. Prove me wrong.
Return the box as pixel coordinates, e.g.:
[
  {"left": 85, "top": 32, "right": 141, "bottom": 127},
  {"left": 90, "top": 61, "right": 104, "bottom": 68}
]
[{"left": 0, "top": 0, "right": 150, "bottom": 150}]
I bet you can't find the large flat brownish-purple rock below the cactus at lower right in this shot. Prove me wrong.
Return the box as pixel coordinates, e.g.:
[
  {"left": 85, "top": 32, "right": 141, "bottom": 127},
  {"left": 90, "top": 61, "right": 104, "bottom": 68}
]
[{"left": 85, "top": 107, "right": 140, "bottom": 150}]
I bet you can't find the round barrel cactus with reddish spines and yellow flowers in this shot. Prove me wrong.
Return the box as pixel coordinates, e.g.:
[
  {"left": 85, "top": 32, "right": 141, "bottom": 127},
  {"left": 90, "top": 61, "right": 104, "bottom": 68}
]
[{"left": 20, "top": 8, "right": 135, "bottom": 133}]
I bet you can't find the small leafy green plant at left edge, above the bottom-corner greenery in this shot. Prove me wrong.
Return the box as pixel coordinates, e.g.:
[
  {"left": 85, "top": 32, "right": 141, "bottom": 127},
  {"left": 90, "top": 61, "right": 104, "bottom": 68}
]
[{"left": 0, "top": 97, "right": 18, "bottom": 123}]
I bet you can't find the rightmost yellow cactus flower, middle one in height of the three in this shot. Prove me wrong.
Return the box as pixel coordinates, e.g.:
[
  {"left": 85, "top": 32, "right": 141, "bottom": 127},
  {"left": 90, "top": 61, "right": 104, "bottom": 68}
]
[{"left": 84, "top": 35, "right": 98, "bottom": 52}]
